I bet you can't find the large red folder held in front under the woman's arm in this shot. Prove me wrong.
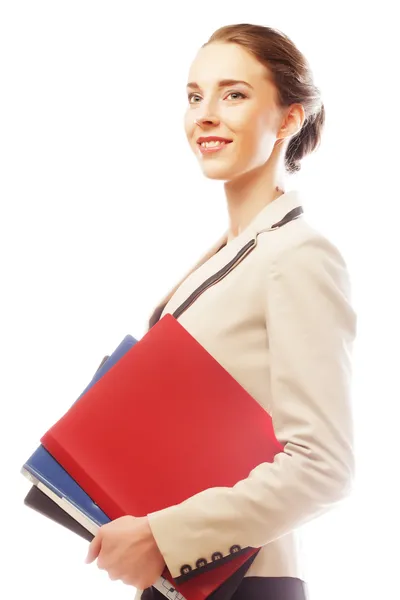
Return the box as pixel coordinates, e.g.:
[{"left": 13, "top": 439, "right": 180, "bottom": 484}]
[{"left": 41, "top": 315, "right": 283, "bottom": 600}]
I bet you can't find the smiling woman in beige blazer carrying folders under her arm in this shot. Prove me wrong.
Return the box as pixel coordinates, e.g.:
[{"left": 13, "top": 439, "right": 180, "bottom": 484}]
[{"left": 88, "top": 25, "right": 356, "bottom": 600}]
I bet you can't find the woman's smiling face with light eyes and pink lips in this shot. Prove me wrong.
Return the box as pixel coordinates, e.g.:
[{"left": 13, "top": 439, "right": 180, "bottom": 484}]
[{"left": 185, "top": 42, "right": 284, "bottom": 181}]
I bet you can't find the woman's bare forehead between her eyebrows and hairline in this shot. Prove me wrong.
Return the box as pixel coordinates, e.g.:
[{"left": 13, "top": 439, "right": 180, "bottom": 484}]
[{"left": 189, "top": 42, "right": 268, "bottom": 86}]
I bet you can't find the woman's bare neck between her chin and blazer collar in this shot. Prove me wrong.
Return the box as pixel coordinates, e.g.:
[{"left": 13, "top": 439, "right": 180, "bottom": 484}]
[{"left": 224, "top": 148, "right": 285, "bottom": 240}]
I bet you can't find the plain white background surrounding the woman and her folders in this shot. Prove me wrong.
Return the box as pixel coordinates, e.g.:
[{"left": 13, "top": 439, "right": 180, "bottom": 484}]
[{"left": 0, "top": 0, "right": 400, "bottom": 600}]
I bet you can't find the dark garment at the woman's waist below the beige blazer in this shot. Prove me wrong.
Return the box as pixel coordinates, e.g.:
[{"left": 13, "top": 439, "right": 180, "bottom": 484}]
[{"left": 141, "top": 576, "right": 308, "bottom": 600}]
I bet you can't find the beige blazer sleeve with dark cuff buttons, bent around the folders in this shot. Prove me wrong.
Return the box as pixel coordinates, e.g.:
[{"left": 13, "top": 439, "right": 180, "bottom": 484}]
[{"left": 148, "top": 234, "right": 357, "bottom": 580}]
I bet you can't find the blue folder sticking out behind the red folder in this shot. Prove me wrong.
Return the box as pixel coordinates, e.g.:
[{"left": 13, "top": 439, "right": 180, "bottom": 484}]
[{"left": 21, "top": 335, "right": 137, "bottom": 527}]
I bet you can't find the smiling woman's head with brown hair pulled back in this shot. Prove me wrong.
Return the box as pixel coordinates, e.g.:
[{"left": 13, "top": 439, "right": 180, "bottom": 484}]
[{"left": 185, "top": 25, "right": 325, "bottom": 185}]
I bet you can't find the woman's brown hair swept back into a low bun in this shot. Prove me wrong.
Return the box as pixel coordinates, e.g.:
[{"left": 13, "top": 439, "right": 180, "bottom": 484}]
[{"left": 203, "top": 23, "right": 325, "bottom": 173}]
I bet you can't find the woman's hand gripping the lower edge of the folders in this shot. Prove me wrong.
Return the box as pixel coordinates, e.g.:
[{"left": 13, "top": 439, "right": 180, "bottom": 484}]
[{"left": 86, "top": 516, "right": 165, "bottom": 590}]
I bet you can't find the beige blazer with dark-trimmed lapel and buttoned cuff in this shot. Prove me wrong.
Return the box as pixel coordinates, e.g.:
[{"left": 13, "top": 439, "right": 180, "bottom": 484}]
[{"left": 136, "top": 190, "right": 357, "bottom": 598}]
